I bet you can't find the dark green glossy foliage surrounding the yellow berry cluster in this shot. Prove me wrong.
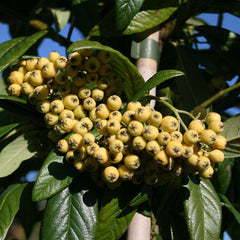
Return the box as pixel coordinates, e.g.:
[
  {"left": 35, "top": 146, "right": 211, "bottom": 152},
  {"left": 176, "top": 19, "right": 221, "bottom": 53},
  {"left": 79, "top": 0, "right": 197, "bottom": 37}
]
[{"left": 0, "top": 0, "right": 240, "bottom": 240}]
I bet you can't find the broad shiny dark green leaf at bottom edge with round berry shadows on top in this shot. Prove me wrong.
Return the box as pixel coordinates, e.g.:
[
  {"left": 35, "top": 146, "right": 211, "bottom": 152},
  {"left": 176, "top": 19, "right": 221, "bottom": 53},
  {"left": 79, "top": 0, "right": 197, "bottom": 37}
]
[{"left": 42, "top": 182, "right": 98, "bottom": 240}]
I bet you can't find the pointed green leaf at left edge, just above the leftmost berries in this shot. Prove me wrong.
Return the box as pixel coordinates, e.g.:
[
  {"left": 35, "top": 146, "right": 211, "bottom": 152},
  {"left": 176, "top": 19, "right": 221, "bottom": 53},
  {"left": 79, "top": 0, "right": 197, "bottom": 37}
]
[{"left": 0, "top": 30, "right": 48, "bottom": 72}]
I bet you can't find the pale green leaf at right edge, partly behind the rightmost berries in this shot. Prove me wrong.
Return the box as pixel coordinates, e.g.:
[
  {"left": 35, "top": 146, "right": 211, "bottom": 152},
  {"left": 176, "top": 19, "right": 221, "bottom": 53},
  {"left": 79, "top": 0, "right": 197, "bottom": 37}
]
[{"left": 220, "top": 115, "right": 240, "bottom": 158}]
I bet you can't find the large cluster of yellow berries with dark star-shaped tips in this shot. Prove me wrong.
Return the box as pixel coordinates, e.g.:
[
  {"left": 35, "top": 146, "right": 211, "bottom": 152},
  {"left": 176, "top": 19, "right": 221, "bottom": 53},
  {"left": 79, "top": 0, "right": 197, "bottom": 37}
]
[{"left": 8, "top": 49, "right": 226, "bottom": 188}]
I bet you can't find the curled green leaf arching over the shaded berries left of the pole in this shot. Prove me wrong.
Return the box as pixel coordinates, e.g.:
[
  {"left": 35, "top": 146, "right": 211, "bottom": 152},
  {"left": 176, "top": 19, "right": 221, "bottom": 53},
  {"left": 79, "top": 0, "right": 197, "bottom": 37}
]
[{"left": 67, "top": 40, "right": 144, "bottom": 99}]
